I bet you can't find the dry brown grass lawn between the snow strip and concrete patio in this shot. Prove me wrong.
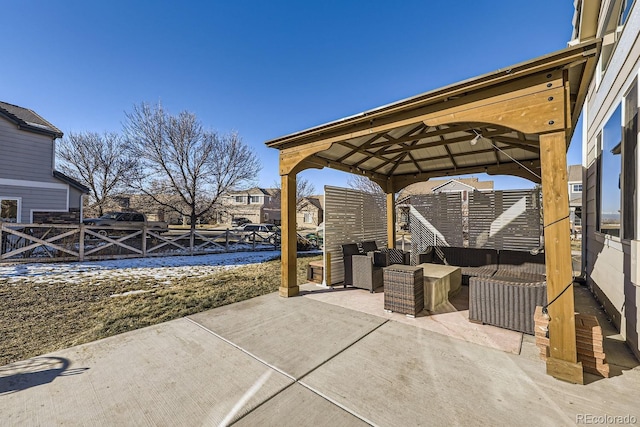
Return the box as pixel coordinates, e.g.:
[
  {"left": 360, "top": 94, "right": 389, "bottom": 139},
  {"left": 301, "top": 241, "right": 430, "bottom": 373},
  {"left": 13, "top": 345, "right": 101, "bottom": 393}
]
[{"left": 0, "top": 256, "right": 322, "bottom": 366}]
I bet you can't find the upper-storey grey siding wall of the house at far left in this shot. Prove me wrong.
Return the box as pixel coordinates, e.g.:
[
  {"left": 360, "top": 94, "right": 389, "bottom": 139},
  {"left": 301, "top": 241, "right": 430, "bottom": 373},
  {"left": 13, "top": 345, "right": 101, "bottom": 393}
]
[{"left": 0, "top": 117, "right": 58, "bottom": 183}]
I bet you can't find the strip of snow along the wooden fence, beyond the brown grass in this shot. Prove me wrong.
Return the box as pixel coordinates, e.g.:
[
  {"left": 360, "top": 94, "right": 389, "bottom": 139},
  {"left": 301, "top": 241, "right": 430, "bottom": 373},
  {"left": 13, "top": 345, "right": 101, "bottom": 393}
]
[{"left": 0, "top": 251, "right": 288, "bottom": 284}]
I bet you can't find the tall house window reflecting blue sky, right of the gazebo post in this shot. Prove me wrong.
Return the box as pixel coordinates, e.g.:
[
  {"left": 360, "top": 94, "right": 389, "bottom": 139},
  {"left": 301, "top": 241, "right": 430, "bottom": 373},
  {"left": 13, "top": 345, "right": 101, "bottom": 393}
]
[{"left": 598, "top": 105, "right": 622, "bottom": 237}]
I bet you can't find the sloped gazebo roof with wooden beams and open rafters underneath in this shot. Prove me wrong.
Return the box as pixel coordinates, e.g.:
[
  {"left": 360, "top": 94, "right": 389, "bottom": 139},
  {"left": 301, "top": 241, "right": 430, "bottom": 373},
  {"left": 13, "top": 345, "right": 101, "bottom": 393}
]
[{"left": 266, "top": 42, "right": 599, "bottom": 189}]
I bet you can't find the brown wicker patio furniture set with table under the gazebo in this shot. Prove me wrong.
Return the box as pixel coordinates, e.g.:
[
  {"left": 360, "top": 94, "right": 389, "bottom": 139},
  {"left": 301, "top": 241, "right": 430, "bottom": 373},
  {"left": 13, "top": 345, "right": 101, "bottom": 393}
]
[{"left": 342, "top": 242, "right": 547, "bottom": 335}]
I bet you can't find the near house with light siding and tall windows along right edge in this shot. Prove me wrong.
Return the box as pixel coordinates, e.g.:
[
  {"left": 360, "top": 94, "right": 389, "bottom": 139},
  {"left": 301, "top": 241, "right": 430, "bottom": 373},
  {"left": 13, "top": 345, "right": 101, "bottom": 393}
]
[{"left": 574, "top": 0, "right": 640, "bottom": 357}]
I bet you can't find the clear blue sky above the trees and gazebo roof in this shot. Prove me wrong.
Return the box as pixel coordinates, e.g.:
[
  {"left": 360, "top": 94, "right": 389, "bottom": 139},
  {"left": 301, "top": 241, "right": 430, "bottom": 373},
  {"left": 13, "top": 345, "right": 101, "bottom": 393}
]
[{"left": 0, "top": 0, "right": 581, "bottom": 192}]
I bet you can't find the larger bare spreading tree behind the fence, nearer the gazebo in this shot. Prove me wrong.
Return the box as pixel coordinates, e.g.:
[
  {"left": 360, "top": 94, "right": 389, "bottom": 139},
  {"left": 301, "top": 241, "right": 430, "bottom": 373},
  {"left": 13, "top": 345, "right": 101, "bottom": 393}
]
[{"left": 124, "top": 103, "right": 260, "bottom": 234}]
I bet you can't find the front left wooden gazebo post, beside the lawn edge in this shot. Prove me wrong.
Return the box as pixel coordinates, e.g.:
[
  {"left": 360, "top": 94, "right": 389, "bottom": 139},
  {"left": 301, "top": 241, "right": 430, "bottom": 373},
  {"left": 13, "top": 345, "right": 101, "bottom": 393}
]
[{"left": 278, "top": 171, "right": 300, "bottom": 297}]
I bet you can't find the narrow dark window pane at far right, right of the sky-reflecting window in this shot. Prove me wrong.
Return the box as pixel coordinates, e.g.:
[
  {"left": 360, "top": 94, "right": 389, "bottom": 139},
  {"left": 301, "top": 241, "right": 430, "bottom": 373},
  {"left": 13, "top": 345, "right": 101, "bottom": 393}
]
[{"left": 622, "top": 83, "right": 638, "bottom": 239}]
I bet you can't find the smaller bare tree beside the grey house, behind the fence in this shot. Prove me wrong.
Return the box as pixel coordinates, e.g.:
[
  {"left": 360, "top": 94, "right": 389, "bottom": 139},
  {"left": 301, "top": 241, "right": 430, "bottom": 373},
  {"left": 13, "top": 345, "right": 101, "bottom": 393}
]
[{"left": 56, "top": 132, "right": 133, "bottom": 215}]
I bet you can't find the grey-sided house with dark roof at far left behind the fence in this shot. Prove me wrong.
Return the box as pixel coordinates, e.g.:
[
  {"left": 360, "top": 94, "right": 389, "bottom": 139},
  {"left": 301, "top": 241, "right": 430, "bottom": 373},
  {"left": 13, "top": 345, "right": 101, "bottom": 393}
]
[{"left": 0, "top": 102, "right": 89, "bottom": 223}]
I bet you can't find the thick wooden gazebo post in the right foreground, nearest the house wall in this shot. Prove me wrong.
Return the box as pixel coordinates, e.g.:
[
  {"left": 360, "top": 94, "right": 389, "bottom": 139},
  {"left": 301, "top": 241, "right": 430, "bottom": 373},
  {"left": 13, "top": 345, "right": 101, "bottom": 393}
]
[{"left": 540, "top": 131, "right": 584, "bottom": 384}]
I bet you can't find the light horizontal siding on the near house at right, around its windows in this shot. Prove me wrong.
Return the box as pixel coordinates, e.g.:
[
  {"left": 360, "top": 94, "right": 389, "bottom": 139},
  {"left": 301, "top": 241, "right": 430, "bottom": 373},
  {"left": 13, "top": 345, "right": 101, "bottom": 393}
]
[{"left": 583, "top": 2, "right": 640, "bottom": 357}]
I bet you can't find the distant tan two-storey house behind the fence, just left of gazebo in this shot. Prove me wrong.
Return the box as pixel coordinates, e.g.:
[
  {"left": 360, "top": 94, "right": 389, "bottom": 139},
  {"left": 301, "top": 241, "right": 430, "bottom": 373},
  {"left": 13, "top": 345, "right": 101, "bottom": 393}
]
[{"left": 218, "top": 187, "right": 280, "bottom": 224}]
